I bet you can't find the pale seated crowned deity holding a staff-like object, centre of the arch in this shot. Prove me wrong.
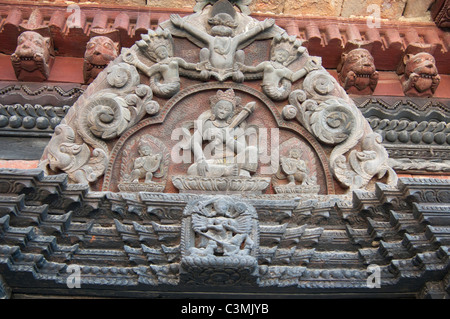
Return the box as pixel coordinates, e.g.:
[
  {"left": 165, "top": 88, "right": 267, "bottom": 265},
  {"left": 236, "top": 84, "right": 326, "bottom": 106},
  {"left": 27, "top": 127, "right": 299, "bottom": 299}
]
[{"left": 187, "top": 89, "right": 258, "bottom": 177}]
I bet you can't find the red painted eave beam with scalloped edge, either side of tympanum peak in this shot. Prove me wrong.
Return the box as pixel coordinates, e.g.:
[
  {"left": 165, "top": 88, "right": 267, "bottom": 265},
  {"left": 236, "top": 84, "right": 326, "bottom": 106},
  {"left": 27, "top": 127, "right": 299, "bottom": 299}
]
[{"left": 0, "top": 1, "right": 450, "bottom": 74}]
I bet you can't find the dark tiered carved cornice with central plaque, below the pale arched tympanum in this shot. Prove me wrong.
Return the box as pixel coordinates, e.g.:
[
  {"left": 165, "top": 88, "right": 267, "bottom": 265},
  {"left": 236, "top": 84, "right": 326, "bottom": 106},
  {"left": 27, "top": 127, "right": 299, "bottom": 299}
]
[{"left": 0, "top": 169, "right": 450, "bottom": 297}]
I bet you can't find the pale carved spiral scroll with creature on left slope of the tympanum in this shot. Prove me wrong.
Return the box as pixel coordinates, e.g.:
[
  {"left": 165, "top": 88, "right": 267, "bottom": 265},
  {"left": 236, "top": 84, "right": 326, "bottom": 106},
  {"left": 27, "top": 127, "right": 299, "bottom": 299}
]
[{"left": 40, "top": 63, "right": 159, "bottom": 184}]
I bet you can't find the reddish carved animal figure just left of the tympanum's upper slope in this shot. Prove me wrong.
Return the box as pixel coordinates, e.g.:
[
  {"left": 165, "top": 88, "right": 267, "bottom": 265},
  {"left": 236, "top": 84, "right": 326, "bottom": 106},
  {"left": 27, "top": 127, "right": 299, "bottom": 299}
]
[{"left": 83, "top": 36, "right": 119, "bottom": 83}]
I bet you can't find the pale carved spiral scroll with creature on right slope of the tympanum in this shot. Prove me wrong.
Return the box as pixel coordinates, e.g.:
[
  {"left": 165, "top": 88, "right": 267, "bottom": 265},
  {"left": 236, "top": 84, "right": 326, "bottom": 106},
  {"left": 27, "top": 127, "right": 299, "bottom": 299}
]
[{"left": 283, "top": 70, "right": 397, "bottom": 189}]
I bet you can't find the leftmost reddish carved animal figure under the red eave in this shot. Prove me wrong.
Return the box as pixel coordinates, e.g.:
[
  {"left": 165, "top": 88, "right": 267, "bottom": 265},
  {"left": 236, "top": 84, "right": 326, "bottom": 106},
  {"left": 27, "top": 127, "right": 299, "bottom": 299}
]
[{"left": 11, "top": 31, "right": 51, "bottom": 81}]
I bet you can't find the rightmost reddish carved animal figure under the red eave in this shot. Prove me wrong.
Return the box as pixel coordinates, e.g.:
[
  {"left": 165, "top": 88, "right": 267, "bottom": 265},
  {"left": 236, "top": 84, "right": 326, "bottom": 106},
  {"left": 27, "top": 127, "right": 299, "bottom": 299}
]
[{"left": 401, "top": 52, "right": 441, "bottom": 97}]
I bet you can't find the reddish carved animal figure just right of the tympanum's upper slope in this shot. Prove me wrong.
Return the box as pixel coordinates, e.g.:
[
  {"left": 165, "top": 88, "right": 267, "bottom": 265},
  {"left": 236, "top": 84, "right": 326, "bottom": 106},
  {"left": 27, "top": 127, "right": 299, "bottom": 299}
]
[{"left": 337, "top": 49, "right": 379, "bottom": 94}]
